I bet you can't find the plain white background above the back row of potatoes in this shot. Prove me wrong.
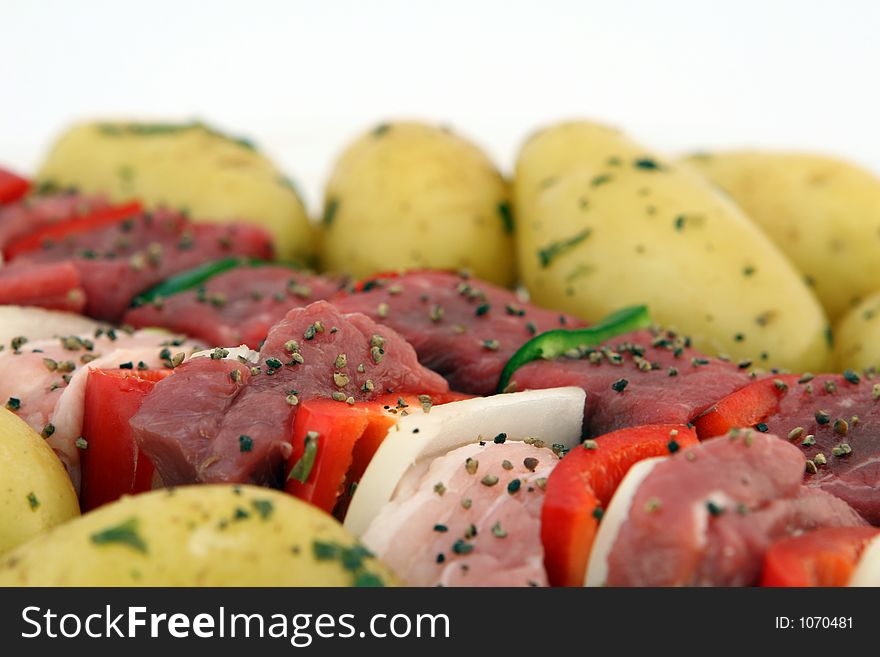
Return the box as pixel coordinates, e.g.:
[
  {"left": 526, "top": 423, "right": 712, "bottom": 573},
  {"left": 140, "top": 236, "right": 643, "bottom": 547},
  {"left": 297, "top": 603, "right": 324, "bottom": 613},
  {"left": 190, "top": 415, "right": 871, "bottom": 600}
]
[{"left": 0, "top": 0, "right": 880, "bottom": 211}]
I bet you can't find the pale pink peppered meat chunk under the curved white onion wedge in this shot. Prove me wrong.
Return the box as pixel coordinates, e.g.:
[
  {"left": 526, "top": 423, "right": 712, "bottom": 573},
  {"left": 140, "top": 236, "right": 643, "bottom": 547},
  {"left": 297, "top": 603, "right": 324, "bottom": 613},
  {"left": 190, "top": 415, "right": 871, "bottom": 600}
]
[{"left": 361, "top": 441, "right": 559, "bottom": 586}]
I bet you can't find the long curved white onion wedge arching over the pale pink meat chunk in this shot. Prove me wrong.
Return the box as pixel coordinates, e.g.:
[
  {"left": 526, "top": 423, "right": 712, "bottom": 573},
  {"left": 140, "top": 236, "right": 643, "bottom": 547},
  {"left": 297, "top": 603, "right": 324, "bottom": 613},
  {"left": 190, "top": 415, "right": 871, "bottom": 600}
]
[{"left": 344, "top": 387, "right": 585, "bottom": 537}]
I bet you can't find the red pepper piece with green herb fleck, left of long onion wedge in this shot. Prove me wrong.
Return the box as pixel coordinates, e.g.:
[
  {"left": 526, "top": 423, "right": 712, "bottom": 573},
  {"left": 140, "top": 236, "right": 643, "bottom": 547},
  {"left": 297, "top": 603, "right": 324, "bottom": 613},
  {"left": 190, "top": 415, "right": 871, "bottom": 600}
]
[{"left": 285, "top": 392, "right": 470, "bottom": 518}]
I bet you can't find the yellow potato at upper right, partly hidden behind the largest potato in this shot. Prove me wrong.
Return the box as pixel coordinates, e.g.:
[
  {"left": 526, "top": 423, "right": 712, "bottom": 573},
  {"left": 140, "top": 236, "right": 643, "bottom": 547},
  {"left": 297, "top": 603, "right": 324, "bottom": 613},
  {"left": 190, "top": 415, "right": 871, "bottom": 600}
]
[{"left": 687, "top": 151, "right": 880, "bottom": 322}]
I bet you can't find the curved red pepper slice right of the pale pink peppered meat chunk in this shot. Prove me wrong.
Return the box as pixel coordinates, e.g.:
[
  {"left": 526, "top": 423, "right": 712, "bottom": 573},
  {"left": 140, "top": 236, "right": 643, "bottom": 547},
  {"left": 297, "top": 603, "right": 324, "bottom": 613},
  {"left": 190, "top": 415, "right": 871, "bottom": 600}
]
[{"left": 541, "top": 424, "right": 699, "bottom": 586}]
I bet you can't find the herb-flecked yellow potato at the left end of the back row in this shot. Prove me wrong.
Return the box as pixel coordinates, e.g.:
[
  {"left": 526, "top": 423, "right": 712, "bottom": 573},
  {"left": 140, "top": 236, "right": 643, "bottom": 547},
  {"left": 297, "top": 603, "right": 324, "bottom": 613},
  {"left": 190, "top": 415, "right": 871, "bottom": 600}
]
[{"left": 38, "top": 123, "right": 315, "bottom": 259}]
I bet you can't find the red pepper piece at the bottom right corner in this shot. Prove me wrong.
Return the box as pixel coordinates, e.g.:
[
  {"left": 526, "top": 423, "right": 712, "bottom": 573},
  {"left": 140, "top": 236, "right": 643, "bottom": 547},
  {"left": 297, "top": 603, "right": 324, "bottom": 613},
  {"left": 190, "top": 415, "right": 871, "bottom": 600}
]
[{"left": 761, "top": 527, "right": 880, "bottom": 586}]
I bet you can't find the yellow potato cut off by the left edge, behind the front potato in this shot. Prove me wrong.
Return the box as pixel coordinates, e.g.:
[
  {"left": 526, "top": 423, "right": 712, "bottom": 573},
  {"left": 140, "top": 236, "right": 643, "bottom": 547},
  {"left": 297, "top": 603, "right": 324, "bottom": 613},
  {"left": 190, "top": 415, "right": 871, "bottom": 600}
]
[{"left": 0, "top": 407, "right": 79, "bottom": 554}]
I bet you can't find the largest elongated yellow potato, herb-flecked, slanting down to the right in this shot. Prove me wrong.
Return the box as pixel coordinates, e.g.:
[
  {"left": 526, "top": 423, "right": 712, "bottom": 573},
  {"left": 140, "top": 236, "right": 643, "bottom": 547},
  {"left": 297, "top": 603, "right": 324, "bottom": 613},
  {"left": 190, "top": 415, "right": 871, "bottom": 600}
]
[{"left": 514, "top": 122, "right": 830, "bottom": 370}]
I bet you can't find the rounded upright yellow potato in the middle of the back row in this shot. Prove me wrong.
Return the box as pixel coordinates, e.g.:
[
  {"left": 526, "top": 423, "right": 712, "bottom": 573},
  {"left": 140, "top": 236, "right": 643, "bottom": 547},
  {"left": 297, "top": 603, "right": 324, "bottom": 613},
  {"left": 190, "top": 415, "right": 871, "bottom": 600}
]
[{"left": 321, "top": 123, "right": 515, "bottom": 285}]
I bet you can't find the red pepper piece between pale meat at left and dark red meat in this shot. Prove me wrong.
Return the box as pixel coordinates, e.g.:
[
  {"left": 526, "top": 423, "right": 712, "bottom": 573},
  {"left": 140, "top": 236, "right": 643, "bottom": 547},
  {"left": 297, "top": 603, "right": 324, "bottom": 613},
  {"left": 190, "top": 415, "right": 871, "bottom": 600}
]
[{"left": 82, "top": 369, "right": 172, "bottom": 511}]
